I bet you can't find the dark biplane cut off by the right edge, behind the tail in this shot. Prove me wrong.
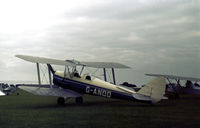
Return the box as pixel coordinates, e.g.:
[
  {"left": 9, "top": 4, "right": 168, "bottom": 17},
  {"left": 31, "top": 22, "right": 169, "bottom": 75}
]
[{"left": 146, "top": 74, "right": 200, "bottom": 98}]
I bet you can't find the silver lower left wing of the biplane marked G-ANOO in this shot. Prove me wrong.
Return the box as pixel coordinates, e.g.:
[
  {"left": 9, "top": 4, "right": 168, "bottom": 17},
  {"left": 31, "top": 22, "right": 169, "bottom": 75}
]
[{"left": 17, "top": 84, "right": 82, "bottom": 98}]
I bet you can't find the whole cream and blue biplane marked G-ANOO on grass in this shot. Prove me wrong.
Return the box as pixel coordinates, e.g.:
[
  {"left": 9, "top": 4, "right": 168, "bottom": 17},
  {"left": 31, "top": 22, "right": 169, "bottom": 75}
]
[{"left": 16, "top": 55, "right": 166, "bottom": 105}]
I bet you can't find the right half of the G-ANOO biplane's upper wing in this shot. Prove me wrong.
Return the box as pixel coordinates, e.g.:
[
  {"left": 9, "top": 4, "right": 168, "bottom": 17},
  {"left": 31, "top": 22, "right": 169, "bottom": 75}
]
[{"left": 81, "top": 62, "right": 130, "bottom": 68}]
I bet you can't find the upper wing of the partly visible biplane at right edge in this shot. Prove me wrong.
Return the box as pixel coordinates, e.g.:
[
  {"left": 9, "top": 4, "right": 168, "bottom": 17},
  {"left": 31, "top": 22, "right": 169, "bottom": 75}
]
[{"left": 145, "top": 74, "right": 200, "bottom": 81}]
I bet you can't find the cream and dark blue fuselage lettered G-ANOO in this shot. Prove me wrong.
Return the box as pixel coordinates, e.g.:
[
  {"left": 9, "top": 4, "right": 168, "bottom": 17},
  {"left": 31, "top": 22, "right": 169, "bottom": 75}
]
[{"left": 53, "top": 71, "right": 140, "bottom": 101}]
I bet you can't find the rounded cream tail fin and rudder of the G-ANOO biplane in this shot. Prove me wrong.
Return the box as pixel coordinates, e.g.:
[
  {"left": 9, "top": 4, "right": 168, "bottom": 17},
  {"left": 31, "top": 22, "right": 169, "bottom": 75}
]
[{"left": 137, "top": 77, "right": 167, "bottom": 104}]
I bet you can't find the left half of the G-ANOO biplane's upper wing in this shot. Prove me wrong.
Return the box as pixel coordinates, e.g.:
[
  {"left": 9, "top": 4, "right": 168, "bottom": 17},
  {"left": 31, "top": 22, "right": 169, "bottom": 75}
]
[{"left": 16, "top": 55, "right": 75, "bottom": 66}]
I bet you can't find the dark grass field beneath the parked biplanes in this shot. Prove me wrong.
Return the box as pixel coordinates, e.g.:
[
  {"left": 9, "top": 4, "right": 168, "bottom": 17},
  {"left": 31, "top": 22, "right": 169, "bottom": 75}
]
[{"left": 0, "top": 90, "right": 200, "bottom": 128}]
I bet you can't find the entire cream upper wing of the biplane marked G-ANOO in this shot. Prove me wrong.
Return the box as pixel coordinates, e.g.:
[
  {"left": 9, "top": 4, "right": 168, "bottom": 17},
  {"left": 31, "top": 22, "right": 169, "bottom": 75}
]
[{"left": 16, "top": 55, "right": 130, "bottom": 68}]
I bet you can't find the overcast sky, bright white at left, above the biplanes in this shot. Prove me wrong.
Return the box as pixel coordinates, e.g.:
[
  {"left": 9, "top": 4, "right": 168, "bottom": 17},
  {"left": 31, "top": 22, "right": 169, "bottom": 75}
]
[{"left": 0, "top": 0, "right": 200, "bottom": 84}]
